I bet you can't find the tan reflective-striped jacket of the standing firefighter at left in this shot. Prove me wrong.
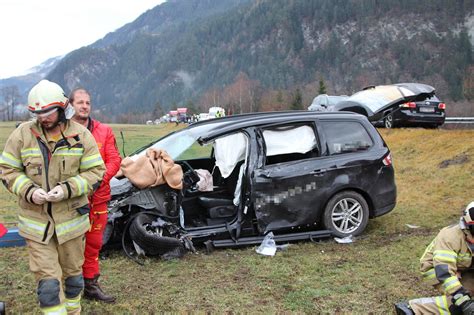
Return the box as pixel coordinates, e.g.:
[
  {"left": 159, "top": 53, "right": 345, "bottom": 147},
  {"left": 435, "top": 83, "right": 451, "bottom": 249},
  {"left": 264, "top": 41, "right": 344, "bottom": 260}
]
[{"left": 0, "top": 120, "right": 105, "bottom": 244}]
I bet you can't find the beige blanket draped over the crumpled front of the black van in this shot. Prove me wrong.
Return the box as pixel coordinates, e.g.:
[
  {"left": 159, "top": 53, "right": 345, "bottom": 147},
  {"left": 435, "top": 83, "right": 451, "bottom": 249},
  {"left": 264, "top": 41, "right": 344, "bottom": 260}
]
[{"left": 117, "top": 148, "right": 183, "bottom": 189}]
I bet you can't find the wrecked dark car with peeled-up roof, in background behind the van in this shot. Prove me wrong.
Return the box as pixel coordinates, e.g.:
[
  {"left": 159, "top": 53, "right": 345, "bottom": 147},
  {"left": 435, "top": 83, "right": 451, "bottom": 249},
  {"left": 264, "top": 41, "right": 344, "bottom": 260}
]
[{"left": 332, "top": 83, "right": 436, "bottom": 126}]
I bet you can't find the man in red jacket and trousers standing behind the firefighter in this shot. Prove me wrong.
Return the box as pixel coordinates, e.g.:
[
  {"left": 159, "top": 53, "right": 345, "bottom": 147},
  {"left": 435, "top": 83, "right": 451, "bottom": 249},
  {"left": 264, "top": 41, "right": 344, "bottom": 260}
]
[{"left": 69, "top": 88, "right": 121, "bottom": 303}]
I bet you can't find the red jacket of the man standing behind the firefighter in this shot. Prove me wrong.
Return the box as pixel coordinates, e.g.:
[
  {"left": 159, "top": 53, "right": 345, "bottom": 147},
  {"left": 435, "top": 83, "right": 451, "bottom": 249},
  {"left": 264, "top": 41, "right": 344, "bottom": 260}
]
[{"left": 87, "top": 119, "right": 122, "bottom": 204}]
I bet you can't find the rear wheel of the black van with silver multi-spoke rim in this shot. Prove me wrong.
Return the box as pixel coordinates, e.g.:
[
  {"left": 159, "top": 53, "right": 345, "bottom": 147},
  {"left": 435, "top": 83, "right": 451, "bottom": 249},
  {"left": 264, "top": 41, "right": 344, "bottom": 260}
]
[{"left": 323, "top": 191, "right": 369, "bottom": 237}]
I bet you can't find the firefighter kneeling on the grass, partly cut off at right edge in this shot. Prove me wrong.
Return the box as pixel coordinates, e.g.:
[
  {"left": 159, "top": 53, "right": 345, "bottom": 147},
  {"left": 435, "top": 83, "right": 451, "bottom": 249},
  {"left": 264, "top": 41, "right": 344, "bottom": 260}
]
[{"left": 396, "top": 201, "right": 474, "bottom": 314}]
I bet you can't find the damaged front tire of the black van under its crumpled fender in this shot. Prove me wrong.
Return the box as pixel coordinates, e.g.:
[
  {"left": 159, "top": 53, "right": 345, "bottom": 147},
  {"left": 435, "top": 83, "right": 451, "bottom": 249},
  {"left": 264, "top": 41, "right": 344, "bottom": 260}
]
[{"left": 130, "top": 213, "right": 184, "bottom": 256}]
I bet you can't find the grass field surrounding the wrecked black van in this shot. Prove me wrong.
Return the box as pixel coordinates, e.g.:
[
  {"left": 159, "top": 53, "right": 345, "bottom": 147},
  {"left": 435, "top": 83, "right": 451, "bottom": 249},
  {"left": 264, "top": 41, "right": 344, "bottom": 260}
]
[{"left": 0, "top": 124, "right": 474, "bottom": 314}]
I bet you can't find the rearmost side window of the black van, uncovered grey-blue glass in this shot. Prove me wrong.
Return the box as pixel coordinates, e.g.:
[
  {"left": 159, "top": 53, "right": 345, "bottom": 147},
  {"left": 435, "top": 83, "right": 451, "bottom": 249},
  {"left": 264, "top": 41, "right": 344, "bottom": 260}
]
[{"left": 322, "top": 121, "right": 374, "bottom": 155}]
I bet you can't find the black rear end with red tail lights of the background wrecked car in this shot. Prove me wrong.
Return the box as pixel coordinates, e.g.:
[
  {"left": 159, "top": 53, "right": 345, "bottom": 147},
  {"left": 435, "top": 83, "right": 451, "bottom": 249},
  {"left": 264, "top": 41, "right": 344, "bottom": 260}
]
[{"left": 383, "top": 95, "right": 446, "bottom": 128}]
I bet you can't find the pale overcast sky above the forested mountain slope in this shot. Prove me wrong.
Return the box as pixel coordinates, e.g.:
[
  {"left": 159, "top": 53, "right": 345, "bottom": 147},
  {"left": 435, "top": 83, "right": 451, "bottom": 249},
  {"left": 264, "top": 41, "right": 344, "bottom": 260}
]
[{"left": 0, "top": 0, "right": 164, "bottom": 78}]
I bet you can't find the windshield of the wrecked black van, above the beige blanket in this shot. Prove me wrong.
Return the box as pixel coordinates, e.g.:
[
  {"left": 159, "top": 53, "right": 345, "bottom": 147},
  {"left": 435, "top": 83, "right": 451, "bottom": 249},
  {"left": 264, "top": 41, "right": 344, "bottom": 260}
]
[{"left": 130, "top": 125, "right": 215, "bottom": 161}]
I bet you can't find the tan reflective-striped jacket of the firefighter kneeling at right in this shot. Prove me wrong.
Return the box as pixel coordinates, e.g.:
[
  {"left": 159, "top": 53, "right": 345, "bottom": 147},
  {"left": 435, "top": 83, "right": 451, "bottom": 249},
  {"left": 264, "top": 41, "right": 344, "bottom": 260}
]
[{"left": 420, "top": 220, "right": 474, "bottom": 295}]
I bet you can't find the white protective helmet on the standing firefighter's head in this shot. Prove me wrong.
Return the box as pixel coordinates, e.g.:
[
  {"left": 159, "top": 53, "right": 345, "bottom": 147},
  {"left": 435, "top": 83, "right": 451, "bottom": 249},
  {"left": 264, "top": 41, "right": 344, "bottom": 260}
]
[{"left": 28, "top": 80, "right": 68, "bottom": 114}]
